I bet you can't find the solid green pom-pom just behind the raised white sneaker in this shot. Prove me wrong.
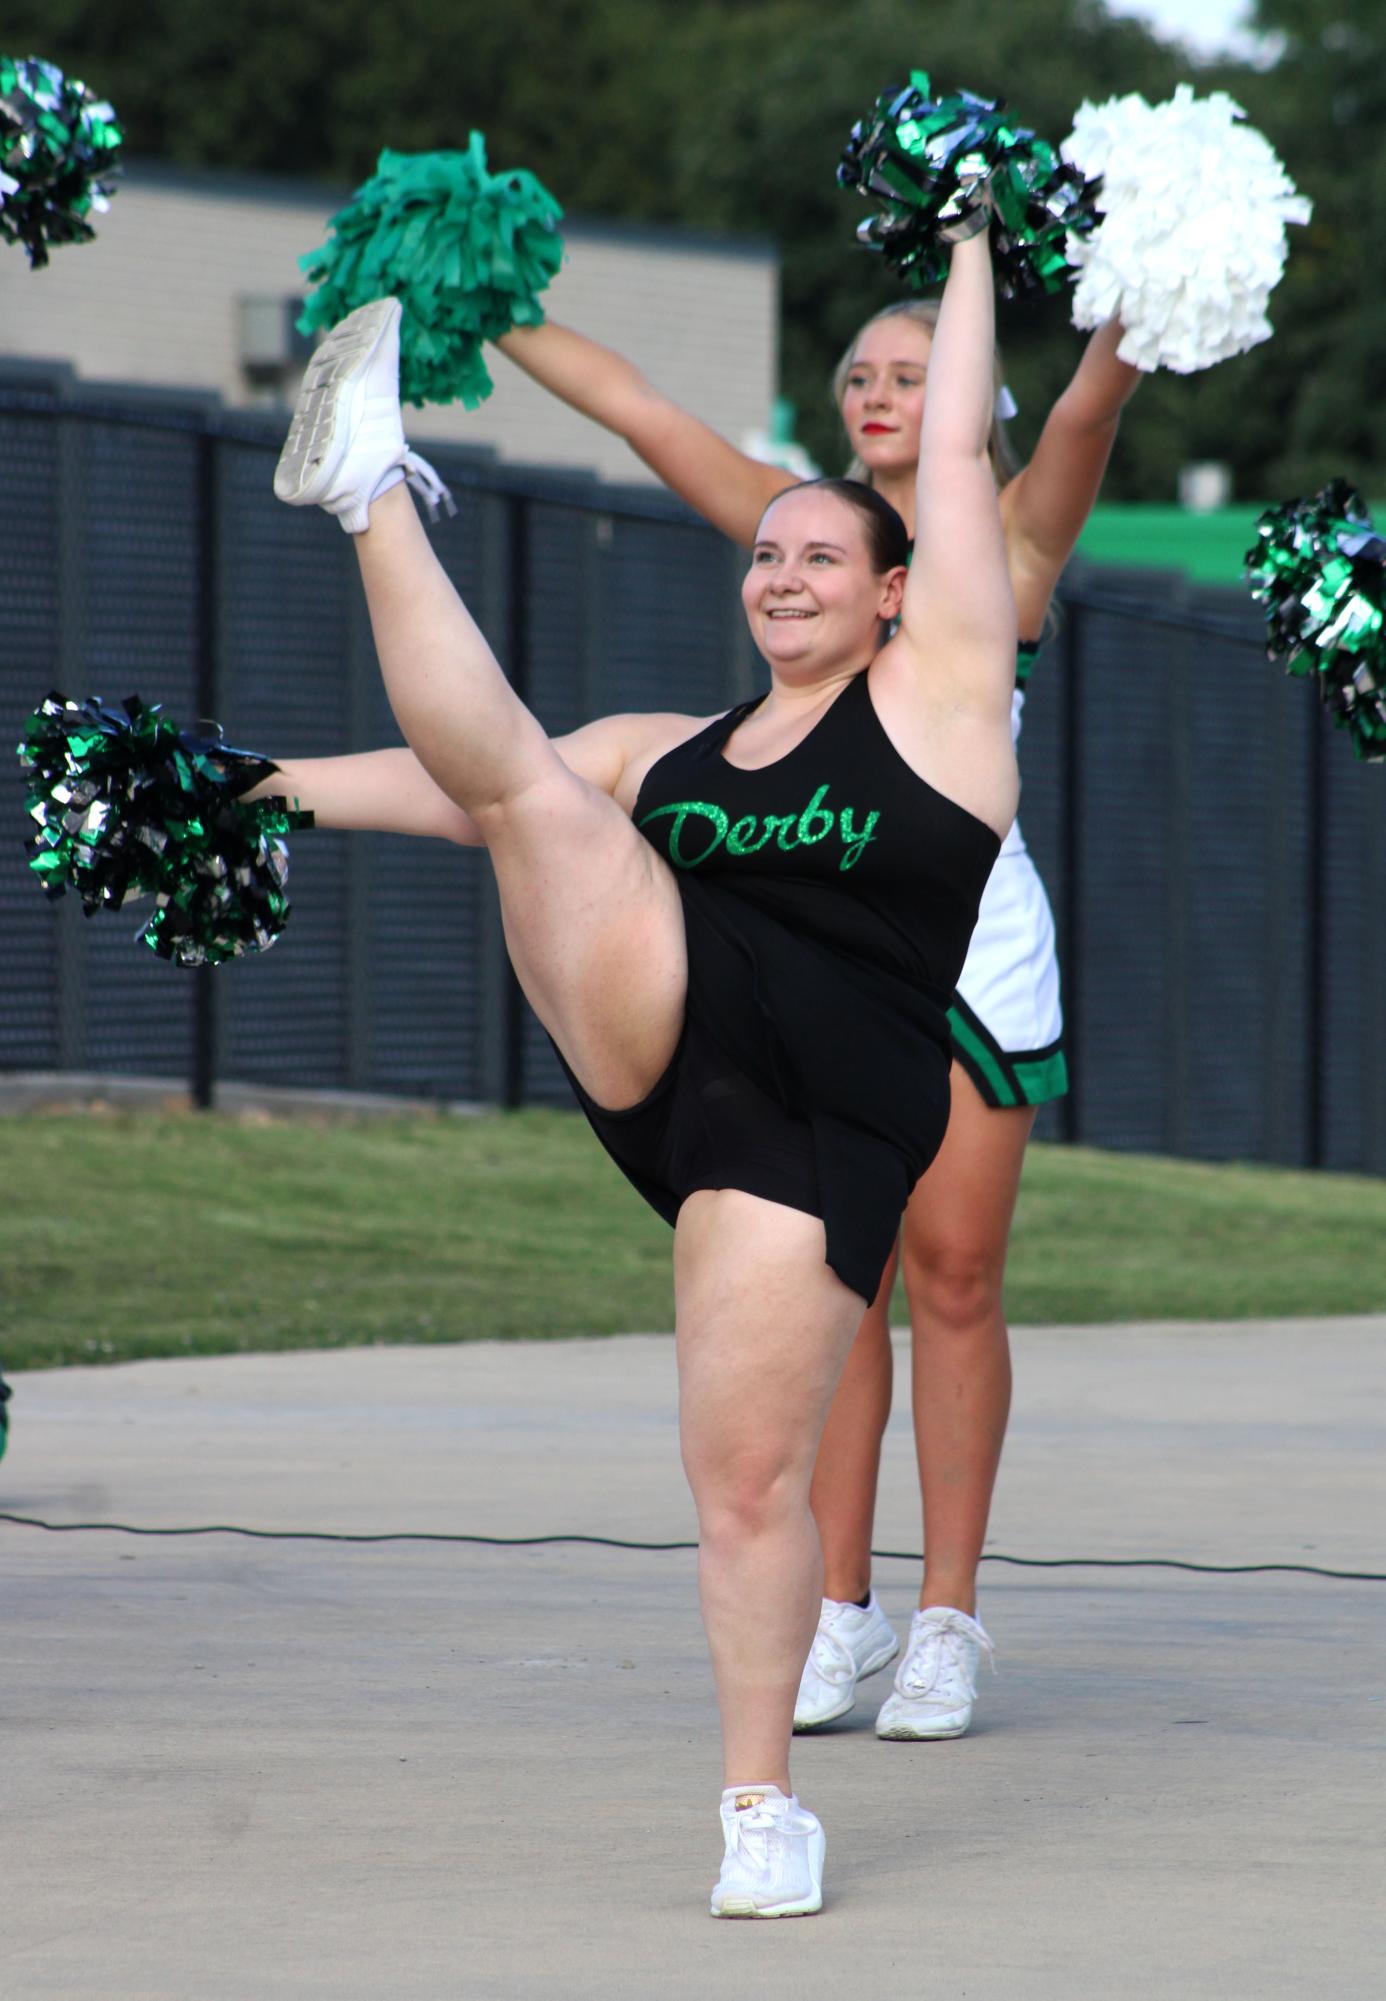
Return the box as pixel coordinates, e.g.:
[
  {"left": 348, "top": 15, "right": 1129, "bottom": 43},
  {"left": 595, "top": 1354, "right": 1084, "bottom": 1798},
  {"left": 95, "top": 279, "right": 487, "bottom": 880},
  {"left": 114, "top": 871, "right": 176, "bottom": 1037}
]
[{"left": 298, "top": 132, "right": 562, "bottom": 410}]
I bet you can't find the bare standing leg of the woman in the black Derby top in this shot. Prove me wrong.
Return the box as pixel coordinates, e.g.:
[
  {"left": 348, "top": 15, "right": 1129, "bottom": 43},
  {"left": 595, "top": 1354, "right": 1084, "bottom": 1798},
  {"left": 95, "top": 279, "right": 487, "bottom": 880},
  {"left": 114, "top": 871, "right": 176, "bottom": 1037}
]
[{"left": 674, "top": 1189, "right": 862, "bottom": 1793}]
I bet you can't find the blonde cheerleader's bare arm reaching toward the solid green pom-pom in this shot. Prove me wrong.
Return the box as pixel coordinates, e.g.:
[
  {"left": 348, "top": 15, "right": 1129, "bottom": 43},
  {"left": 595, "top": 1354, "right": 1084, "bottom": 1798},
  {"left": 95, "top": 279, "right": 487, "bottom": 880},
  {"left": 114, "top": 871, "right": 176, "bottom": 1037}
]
[{"left": 496, "top": 320, "right": 796, "bottom": 548}]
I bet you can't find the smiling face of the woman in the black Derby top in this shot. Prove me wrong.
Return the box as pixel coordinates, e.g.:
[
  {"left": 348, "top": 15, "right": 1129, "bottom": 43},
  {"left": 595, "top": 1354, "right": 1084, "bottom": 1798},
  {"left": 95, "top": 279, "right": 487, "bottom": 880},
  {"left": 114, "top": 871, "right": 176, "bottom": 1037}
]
[{"left": 742, "top": 486, "right": 904, "bottom": 680}]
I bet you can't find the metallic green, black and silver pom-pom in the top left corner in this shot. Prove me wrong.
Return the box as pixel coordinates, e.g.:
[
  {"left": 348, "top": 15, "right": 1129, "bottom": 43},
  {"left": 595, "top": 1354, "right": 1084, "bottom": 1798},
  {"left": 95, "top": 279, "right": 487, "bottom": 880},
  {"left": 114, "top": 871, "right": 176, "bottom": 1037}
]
[{"left": 0, "top": 56, "right": 124, "bottom": 270}]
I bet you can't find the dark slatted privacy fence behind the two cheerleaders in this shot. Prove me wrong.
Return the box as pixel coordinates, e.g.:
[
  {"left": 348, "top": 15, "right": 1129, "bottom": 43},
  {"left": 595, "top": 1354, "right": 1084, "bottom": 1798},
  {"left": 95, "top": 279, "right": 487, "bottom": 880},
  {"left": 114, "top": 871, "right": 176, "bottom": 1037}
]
[{"left": 0, "top": 370, "right": 1386, "bottom": 1173}]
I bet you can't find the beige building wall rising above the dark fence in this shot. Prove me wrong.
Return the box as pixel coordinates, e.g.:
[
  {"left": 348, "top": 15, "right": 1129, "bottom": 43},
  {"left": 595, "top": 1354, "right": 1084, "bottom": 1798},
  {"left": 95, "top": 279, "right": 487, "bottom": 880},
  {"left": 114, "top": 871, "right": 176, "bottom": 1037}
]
[{"left": 0, "top": 164, "right": 780, "bottom": 480}]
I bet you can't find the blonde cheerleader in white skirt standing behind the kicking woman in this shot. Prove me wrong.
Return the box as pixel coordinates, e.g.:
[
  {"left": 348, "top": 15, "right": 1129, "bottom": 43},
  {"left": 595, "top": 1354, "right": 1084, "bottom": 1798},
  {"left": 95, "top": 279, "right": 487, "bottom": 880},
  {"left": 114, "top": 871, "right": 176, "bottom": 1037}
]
[{"left": 498, "top": 298, "right": 1140, "bottom": 1737}]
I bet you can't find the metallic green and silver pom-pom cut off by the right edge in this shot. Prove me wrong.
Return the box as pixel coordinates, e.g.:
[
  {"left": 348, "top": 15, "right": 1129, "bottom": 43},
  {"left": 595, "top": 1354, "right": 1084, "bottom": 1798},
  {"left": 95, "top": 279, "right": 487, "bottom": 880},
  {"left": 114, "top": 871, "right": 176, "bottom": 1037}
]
[{"left": 1246, "top": 480, "right": 1386, "bottom": 762}]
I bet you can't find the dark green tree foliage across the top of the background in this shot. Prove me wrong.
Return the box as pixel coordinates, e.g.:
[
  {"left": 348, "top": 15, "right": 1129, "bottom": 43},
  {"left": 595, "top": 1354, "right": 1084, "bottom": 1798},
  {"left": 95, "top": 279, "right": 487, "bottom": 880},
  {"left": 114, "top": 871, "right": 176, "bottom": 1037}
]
[{"left": 13, "top": 0, "right": 1386, "bottom": 498}]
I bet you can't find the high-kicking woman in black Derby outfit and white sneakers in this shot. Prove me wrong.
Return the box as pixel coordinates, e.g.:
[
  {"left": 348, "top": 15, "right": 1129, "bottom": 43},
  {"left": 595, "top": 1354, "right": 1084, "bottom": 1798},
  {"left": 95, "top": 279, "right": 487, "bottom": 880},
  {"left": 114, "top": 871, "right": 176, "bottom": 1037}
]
[{"left": 264, "top": 234, "right": 1018, "bottom": 1917}]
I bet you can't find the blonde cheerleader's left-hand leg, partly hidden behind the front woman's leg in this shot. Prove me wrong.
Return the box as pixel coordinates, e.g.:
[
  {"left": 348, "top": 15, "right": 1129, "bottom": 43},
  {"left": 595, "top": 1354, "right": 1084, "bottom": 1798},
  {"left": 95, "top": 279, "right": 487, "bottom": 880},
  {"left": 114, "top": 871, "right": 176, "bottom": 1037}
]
[{"left": 812, "top": 1249, "right": 900, "bottom": 1605}]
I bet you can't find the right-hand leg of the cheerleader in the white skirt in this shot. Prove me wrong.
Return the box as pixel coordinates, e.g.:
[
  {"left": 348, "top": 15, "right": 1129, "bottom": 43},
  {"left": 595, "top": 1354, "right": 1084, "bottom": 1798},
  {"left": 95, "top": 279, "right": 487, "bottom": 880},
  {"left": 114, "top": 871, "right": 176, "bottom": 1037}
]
[{"left": 904, "top": 1065, "right": 1036, "bottom": 1615}]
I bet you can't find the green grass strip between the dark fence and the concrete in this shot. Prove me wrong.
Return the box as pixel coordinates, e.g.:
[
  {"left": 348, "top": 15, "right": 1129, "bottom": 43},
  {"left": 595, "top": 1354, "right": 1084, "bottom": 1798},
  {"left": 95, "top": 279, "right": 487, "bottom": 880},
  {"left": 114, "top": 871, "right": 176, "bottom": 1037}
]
[{"left": 0, "top": 1113, "right": 1386, "bottom": 1369}]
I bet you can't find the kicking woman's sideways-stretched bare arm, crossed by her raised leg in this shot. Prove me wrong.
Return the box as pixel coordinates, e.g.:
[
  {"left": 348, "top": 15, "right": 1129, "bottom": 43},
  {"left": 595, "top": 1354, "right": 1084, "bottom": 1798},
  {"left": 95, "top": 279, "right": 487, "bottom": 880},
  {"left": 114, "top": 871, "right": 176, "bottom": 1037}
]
[{"left": 246, "top": 714, "right": 698, "bottom": 848}]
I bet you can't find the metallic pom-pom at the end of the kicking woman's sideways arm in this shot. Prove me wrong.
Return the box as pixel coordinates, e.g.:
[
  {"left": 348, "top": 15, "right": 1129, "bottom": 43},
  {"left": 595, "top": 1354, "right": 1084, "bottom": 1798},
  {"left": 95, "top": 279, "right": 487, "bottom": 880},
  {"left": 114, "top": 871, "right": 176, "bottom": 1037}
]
[{"left": 20, "top": 694, "right": 312, "bottom": 966}]
